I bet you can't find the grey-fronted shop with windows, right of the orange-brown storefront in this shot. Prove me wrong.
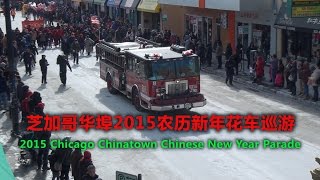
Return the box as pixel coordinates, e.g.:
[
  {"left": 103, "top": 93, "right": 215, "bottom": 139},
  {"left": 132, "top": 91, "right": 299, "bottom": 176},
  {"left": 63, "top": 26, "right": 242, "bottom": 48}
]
[{"left": 235, "top": 0, "right": 277, "bottom": 63}]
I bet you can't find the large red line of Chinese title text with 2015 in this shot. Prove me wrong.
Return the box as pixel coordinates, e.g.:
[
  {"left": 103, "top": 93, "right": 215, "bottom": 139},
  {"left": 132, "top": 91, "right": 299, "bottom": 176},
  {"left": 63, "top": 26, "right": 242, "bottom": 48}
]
[{"left": 27, "top": 114, "right": 295, "bottom": 132}]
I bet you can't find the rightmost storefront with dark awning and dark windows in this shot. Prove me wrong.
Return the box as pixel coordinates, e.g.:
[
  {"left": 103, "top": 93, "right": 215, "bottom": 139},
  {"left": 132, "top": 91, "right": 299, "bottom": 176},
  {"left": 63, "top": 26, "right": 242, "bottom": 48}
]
[{"left": 275, "top": 3, "right": 320, "bottom": 63}]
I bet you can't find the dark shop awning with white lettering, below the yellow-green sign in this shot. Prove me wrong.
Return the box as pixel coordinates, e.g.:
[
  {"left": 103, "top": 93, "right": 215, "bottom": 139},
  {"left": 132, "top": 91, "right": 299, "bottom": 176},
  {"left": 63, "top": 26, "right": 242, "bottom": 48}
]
[{"left": 275, "top": 3, "right": 320, "bottom": 31}]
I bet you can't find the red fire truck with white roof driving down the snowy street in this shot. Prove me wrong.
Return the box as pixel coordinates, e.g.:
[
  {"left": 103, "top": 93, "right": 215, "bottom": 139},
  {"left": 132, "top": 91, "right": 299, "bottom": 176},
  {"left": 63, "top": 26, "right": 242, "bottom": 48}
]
[{"left": 97, "top": 38, "right": 206, "bottom": 111}]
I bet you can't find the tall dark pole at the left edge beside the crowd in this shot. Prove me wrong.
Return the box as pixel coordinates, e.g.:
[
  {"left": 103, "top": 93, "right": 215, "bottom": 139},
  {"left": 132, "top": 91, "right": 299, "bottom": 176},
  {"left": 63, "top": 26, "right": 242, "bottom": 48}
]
[{"left": 4, "top": 0, "right": 19, "bottom": 135}]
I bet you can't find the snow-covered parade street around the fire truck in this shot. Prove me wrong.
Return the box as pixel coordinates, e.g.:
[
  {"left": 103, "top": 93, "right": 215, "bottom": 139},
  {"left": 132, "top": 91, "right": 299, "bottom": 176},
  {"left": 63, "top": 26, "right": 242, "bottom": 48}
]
[{"left": 0, "top": 13, "right": 320, "bottom": 180}]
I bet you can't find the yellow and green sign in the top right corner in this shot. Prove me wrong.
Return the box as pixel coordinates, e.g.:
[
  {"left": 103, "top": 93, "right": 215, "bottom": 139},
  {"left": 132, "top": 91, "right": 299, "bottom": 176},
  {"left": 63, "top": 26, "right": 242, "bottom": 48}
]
[{"left": 291, "top": 0, "right": 320, "bottom": 17}]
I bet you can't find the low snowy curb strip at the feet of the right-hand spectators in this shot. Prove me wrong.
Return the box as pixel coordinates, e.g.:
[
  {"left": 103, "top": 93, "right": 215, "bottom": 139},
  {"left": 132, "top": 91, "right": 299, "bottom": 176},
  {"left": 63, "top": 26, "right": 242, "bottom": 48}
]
[{"left": 201, "top": 69, "right": 320, "bottom": 108}]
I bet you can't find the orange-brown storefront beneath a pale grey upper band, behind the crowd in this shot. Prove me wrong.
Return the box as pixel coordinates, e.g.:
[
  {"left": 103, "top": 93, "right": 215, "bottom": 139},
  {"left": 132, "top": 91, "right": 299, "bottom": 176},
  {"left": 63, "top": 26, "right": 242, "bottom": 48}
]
[{"left": 159, "top": 0, "right": 237, "bottom": 47}]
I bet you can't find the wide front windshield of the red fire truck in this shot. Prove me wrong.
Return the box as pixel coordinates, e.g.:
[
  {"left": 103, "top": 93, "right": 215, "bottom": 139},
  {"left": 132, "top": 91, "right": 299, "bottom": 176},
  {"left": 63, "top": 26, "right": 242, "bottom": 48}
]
[{"left": 146, "top": 57, "right": 200, "bottom": 81}]
